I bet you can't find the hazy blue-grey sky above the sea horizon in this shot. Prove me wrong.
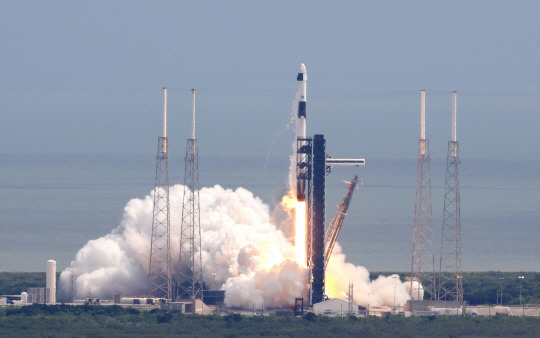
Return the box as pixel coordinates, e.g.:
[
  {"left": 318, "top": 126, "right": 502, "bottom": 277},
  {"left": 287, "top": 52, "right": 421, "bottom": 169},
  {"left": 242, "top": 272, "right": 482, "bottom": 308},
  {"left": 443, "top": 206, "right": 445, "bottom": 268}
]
[{"left": 0, "top": 0, "right": 540, "bottom": 159}]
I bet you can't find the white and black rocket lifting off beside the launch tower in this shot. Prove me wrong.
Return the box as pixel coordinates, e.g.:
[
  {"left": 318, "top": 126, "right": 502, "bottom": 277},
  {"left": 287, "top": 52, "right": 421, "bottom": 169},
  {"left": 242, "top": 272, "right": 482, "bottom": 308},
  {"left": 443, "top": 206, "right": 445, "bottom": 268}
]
[{"left": 296, "top": 63, "right": 307, "bottom": 201}]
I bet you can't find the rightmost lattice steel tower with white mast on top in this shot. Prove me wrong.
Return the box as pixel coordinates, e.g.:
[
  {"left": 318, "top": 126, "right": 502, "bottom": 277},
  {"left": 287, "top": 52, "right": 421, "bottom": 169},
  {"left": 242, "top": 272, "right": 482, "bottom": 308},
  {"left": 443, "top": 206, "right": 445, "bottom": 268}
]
[{"left": 438, "top": 92, "right": 463, "bottom": 302}]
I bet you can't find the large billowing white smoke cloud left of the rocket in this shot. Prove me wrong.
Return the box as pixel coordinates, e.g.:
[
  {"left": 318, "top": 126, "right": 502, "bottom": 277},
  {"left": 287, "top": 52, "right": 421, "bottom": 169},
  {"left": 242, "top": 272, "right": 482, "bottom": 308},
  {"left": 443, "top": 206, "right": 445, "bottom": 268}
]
[{"left": 59, "top": 185, "right": 308, "bottom": 308}]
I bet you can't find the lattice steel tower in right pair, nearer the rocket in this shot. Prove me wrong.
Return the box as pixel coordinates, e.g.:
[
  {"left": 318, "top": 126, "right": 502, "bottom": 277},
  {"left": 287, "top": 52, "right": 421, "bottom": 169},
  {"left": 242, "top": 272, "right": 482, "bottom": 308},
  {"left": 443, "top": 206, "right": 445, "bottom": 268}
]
[{"left": 409, "top": 90, "right": 436, "bottom": 300}]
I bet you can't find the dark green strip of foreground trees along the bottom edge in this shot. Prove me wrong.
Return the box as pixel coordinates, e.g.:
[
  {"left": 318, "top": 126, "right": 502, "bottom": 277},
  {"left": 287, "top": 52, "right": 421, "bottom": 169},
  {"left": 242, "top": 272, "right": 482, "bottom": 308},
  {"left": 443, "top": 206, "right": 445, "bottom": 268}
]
[{"left": 0, "top": 305, "right": 540, "bottom": 337}]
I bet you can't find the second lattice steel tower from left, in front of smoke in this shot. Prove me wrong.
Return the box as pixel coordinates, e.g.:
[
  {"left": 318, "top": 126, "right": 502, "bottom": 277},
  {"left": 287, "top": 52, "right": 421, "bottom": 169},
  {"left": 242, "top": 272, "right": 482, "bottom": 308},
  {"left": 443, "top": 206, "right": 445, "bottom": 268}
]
[{"left": 178, "top": 89, "right": 203, "bottom": 299}]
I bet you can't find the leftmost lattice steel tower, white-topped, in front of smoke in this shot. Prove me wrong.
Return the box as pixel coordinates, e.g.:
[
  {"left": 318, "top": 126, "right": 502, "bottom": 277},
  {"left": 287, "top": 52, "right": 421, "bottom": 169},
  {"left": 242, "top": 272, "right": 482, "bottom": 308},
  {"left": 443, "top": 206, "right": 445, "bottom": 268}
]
[{"left": 148, "top": 88, "right": 172, "bottom": 299}]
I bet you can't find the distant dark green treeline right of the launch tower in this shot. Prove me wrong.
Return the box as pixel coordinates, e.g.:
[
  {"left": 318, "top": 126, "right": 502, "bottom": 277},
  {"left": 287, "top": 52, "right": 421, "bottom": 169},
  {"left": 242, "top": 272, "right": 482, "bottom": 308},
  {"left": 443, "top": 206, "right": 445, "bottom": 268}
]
[{"left": 370, "top": 271, "right": 540, "bottom": 305}]
